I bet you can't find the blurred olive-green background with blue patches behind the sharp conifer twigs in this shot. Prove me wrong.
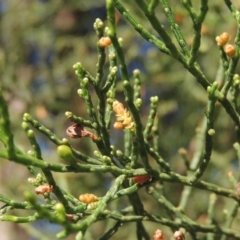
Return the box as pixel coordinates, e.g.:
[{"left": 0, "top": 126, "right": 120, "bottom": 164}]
[{"left": 0, "top": 0, "right": 240, "bottom": 240}]
